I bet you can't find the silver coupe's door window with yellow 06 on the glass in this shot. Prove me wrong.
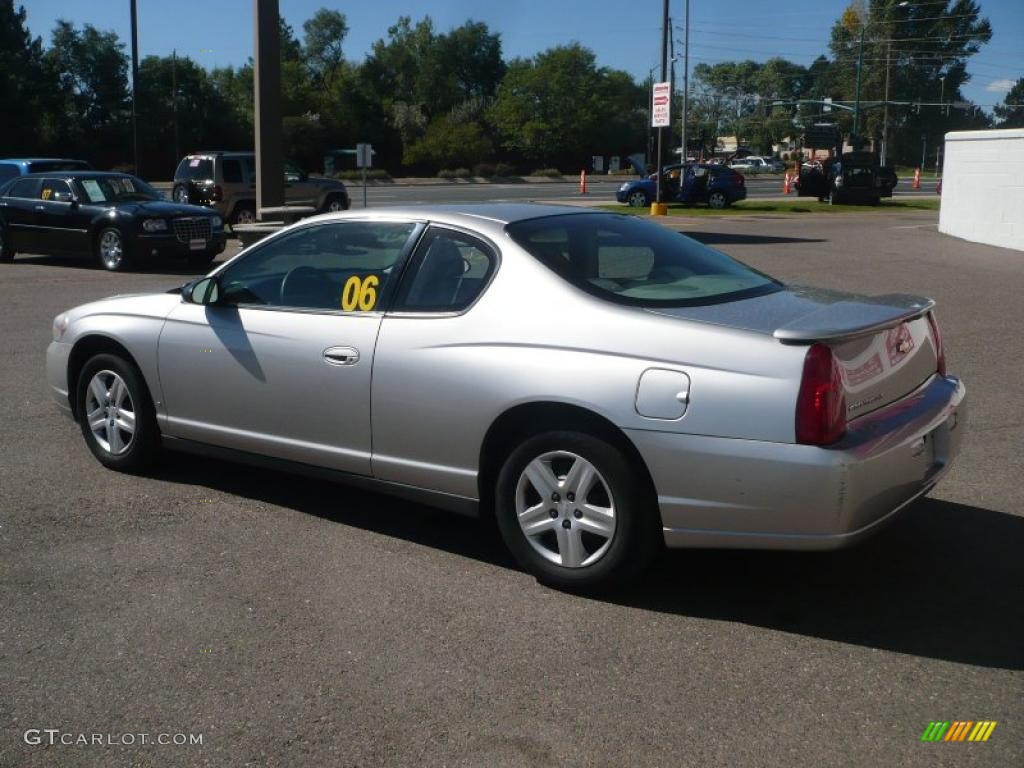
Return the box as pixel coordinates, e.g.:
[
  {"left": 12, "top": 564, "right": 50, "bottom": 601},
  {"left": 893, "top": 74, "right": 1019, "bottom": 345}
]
[{"left": 219, "top": 221, "right": 416, "bottom": 312}]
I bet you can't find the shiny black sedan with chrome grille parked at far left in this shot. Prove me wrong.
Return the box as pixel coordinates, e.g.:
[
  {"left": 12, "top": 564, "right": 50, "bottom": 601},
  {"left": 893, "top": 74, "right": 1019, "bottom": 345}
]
[{"left": 0, "top": 171, "right": 226, "bottom": 271}]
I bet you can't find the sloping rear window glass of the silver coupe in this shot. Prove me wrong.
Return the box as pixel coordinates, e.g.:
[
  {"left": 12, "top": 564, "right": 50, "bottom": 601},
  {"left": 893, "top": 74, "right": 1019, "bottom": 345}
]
[{"left": 507, "top": 213, "right": 781, "bottom": 307}]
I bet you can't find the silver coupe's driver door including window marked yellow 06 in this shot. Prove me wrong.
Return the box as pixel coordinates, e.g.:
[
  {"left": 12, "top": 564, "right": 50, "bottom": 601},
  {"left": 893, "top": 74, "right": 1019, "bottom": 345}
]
[{"left": 158, "top": 221, "right": 422, "bottom": 475}]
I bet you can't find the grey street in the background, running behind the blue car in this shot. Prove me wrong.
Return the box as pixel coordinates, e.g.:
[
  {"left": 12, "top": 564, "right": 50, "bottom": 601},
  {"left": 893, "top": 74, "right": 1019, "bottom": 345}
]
[{"left": 346, "top": 176, "right": 935, "bottom": 208}]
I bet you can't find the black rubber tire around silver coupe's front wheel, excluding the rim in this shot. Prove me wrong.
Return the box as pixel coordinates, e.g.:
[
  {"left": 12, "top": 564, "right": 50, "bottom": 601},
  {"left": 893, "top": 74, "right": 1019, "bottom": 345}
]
[{"left": 75, "top": 353, "right": 160, "bottom": 472}]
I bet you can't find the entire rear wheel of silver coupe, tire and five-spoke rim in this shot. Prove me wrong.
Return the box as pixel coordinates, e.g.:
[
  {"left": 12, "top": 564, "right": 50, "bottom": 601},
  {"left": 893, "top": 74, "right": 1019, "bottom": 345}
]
[{"left": 495, "top": 431, "right": 659, "bottom": 590}]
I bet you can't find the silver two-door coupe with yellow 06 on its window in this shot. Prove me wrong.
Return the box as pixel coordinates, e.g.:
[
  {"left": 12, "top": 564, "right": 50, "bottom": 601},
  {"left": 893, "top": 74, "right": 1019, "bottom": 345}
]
[{"left": 47, "top": 205, "right": 966, "bottom": 588}]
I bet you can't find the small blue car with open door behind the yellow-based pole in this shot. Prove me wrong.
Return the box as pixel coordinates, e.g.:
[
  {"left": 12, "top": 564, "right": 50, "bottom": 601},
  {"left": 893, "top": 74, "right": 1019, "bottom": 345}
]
[{"left": 615, "top": 163, "right": 746, "bottom": 208}]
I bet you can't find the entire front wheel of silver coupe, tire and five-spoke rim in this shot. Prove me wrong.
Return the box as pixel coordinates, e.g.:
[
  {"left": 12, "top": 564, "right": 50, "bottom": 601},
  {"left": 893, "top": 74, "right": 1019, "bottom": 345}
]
[{"left": 76, "top": 353, "right": 160, "bottom": 472}]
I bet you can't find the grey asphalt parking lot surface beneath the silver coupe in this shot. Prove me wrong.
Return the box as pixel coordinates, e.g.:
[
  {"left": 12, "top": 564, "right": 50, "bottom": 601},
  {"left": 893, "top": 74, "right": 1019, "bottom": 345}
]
[{"left": 0, "top": 207, "right": 1024, "bottom": 766}]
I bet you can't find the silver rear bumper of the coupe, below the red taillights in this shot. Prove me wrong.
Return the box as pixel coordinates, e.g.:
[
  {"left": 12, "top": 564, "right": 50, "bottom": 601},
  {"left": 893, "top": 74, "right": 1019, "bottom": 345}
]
[{"left": 629, "top": 376, "right": 967, "bottom": 549}]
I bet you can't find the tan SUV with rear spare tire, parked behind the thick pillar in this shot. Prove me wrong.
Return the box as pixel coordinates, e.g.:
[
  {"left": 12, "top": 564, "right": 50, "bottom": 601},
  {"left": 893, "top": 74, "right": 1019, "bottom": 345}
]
[{"left": 172, "top": 152, "right": 349, "bottom": 224}]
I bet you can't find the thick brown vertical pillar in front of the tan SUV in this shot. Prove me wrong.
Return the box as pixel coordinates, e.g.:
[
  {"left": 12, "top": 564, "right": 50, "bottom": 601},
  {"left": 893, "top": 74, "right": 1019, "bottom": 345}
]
[{"left": 253, "top": 0, "right": 285, "bottom": 218}]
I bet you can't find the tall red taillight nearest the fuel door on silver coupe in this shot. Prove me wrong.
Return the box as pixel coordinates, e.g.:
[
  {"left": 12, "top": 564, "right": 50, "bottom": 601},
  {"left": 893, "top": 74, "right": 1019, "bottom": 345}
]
[{"left": 797, "top": 344, "right": 846, "bottom": 445}]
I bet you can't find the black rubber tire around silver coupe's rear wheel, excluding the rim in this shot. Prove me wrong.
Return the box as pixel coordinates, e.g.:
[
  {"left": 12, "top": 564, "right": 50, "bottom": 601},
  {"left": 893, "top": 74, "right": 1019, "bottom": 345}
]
[{"left": 495, "top": 431, "right": 664, "bottom": 591}]
